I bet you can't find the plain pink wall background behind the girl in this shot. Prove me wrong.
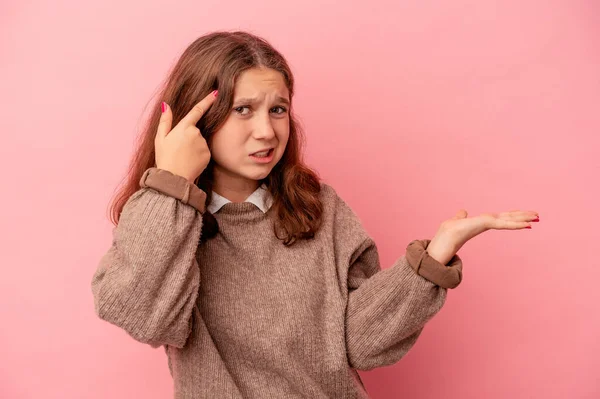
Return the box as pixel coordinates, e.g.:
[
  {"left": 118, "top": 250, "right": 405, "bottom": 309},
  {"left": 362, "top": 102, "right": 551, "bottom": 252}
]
[{"left": 0, "top": 0, "right": 600, "bottom": 399}]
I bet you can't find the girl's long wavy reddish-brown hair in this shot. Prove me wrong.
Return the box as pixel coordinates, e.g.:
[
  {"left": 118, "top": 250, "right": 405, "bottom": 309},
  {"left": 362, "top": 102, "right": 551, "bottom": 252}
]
[{"left": 109, "top": 31, "right": 323, "bottom": 246}]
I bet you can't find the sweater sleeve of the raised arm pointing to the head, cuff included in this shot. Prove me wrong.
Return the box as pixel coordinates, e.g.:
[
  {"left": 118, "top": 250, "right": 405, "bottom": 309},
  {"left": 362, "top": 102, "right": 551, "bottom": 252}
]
[{"left": 92, "top": 168, "right": 206, "bottom": 348}]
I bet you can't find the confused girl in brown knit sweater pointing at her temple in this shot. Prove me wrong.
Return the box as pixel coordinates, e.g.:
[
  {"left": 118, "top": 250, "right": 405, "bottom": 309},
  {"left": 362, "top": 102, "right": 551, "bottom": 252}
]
[{"left": 92, "top": 32, "right": 539, "bottom": 398}]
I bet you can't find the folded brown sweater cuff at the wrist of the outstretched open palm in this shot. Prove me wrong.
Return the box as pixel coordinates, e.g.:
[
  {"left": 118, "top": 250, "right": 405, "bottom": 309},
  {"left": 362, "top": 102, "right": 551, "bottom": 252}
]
[{"left": 406, "top": 240, "right": 462, "bottom": 288}]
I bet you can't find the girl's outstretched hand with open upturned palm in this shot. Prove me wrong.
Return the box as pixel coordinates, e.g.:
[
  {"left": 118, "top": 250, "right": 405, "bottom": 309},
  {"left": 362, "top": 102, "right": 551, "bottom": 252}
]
[{"left": 427, "top": 209, "right": 540, "bottom": 265}]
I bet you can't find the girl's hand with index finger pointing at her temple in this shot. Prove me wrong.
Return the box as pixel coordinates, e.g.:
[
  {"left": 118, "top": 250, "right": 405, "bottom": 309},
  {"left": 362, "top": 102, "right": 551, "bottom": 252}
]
[{"left": 154, "top": 90, "right": 217, "bottom": 183}]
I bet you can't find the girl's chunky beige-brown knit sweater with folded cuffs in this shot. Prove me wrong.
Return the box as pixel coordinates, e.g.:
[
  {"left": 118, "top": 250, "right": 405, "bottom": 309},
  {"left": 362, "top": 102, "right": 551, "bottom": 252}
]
[{"left": 92, "top": 168, "right": 462, "bottom": 399}]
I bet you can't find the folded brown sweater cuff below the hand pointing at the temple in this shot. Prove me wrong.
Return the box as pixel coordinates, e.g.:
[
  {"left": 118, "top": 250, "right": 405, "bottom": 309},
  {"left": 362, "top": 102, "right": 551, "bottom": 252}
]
[{"left": 140, "top": 168, "right": 206, "bottom": 214}]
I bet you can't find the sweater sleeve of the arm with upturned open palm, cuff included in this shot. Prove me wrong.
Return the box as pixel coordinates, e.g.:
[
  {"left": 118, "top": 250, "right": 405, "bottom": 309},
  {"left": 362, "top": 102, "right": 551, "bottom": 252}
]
[{"left": 335, "top": 197, "right": 462, "bottom": 370}]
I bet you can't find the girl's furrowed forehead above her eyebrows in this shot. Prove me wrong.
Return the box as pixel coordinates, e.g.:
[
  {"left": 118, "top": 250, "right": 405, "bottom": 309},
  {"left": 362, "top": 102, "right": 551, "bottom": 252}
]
[{"left": 234, "top": 68, "right": 289, "bottom": 98}]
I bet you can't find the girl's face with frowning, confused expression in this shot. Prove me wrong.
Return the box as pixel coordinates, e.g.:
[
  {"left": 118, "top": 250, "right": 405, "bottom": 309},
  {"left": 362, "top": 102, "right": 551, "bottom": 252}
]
[{"left": 210, "top": 68, "right": 290, "bottom": 187}]
